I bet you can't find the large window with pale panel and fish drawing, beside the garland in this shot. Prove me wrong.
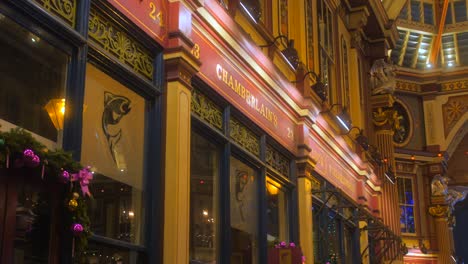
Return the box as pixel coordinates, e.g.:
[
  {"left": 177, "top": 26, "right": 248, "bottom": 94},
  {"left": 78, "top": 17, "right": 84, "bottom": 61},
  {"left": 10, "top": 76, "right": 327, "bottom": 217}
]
[{"left": 81, "top": 64, "right": 146, "bottom": 255}]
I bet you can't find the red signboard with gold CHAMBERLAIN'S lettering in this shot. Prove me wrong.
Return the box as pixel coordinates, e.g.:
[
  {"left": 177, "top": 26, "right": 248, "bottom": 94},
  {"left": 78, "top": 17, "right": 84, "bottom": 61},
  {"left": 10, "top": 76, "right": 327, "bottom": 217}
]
[{"left": 192, "top": 29, "right": 296, "bottom": 153}]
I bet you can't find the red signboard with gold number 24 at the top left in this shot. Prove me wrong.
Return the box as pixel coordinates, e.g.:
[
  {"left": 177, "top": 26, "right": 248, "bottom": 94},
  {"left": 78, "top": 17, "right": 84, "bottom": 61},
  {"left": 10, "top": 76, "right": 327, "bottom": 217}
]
[{"left": 108, "top": 0, "right": 168, "bottom": 44}]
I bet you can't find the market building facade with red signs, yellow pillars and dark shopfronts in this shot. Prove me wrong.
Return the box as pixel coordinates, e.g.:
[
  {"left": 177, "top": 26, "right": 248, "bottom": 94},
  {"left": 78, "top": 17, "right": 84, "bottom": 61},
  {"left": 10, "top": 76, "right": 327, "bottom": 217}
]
[{"left": 0, "top": 0, "right": 428, "bottom": 263}]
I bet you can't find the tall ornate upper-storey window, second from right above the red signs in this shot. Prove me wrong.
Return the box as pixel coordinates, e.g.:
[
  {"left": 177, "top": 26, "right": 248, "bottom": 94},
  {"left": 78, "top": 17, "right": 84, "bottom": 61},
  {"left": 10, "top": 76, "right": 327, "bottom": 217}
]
[{"left": 317, "top": 1, "right": 334, "bottom": 100}]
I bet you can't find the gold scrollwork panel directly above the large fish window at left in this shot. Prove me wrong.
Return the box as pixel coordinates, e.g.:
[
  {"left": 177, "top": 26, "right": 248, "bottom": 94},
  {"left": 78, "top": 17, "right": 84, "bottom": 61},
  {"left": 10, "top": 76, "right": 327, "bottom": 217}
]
[{"left": 88, "top": 10, "right": 153, "bottom": 80}]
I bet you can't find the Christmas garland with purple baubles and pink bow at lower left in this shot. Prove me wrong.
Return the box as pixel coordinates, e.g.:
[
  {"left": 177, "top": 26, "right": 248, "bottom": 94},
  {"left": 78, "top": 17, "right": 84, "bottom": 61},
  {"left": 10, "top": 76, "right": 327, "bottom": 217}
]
[{"left": 0, "top": 128, "right": 92, "bottom": 258}]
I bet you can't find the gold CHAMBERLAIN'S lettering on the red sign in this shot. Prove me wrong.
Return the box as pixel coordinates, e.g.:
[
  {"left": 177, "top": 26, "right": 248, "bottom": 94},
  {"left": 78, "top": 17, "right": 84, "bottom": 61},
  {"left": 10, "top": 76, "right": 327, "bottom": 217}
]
[{"left": 216, "top": 64, "right": 278, "bottom": 127}]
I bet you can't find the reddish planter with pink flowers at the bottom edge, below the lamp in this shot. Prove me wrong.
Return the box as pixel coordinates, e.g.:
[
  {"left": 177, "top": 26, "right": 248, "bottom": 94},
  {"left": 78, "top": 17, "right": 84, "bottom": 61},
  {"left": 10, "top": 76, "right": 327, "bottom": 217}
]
[{"left": 268, "top": 241, "right": 306, "bottom": 264}]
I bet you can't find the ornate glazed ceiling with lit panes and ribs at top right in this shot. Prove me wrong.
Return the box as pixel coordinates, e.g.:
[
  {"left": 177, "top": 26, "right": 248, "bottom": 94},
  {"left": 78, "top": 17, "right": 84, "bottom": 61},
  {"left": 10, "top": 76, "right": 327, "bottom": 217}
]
[{"left": 391, "top": 0, "right": 468, "bottom": 70}]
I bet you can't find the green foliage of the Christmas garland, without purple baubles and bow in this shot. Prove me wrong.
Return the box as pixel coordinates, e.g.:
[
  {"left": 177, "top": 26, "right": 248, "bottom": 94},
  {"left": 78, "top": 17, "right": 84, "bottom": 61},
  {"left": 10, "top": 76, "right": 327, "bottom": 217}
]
[{"left": 0, "top": 128, "right": 91, "bottom": 258}]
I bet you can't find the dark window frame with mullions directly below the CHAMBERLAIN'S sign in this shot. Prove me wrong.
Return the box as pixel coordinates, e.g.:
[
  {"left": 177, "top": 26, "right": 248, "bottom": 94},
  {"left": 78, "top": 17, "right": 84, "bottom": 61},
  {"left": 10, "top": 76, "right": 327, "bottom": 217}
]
[{"left": 191, "top": 80, "right": 298, "bottom": 263}]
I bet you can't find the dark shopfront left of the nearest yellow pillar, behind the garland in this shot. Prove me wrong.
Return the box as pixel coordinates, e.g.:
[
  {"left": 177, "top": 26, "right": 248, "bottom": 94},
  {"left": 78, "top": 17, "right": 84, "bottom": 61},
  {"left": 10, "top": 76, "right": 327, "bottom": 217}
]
[{"left": 0, "top": 1, "right": 162, "bottom": 264}]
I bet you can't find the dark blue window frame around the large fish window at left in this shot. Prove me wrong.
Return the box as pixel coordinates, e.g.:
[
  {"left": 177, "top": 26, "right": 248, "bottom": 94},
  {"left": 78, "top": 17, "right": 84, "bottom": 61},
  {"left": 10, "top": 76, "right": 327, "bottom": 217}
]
[{"left": 0, "top": 0, "right": 164, "bottom": 264}]
